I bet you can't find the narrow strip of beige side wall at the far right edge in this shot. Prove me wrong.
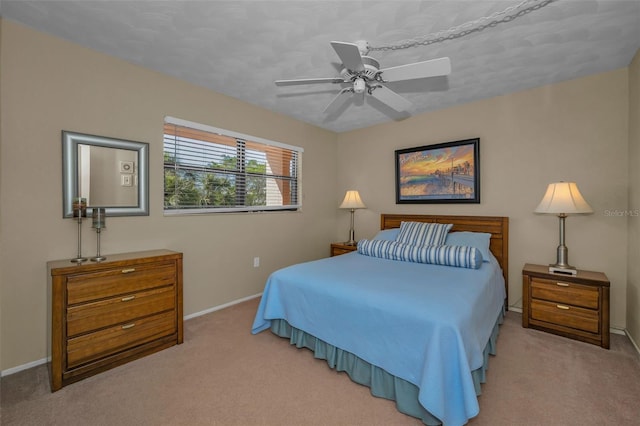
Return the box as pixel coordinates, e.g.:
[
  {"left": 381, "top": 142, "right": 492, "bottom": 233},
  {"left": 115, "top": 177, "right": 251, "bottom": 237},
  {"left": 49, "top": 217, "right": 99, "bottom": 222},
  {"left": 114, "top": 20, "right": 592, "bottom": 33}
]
[{"left": 627, "top": 50, "right": 640, "bottom": 347}]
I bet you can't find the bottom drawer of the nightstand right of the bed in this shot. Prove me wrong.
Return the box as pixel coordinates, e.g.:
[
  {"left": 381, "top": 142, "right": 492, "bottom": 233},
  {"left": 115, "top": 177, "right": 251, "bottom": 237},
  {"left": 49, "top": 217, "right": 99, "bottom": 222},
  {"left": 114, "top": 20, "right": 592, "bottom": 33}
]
[{"left": 531, "top": 299, "right": 600, "bottom": 333}]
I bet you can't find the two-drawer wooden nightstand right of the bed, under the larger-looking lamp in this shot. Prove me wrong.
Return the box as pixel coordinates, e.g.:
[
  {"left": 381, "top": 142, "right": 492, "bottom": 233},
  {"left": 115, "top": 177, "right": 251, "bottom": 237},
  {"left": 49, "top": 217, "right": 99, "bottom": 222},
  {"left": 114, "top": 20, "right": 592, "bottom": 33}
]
[{"left": 522, "top": 263, "right": 610, "bottom": 349}]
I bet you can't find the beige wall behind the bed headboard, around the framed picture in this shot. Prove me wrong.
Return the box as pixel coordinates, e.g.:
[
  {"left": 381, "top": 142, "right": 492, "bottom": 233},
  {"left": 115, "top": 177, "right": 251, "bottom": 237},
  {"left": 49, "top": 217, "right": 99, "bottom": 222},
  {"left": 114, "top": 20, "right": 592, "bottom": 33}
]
[{"left": 338, "top": 69, "right": 629, "bottom": 328}]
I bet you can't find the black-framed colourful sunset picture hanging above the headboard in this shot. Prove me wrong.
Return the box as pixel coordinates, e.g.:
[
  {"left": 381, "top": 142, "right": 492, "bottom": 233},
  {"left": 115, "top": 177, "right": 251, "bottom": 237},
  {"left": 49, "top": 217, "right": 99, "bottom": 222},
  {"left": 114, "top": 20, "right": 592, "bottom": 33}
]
[{"left": 396, "top": 138, "right": 480, "bottom": 204}]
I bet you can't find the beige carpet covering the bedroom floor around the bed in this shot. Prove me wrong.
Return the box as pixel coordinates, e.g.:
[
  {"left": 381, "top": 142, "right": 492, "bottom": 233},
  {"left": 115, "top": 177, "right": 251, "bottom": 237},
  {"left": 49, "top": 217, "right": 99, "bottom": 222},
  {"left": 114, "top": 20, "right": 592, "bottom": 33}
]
[{"left": 0, "top": 299, "right": 640, "bottom": 426}]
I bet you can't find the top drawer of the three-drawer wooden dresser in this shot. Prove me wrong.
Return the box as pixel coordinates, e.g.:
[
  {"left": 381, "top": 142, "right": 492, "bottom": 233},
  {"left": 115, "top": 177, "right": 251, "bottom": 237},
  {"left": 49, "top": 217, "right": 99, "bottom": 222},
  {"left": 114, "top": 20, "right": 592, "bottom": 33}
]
[{"left": 67, "top": 262, "right": 176, "bottom": 305}]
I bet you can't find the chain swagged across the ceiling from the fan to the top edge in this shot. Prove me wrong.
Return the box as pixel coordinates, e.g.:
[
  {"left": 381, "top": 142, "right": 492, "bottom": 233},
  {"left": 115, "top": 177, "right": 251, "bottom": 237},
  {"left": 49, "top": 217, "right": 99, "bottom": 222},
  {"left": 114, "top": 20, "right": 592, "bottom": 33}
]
[{"left": 369, "top": 0, "right": 558, "bottom": 51}]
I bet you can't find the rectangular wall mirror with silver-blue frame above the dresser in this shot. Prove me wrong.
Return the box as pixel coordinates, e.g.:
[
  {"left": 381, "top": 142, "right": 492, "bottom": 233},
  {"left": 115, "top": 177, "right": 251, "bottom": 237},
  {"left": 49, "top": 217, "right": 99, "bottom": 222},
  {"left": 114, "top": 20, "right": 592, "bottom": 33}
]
[{"left": 62, "top": 130, "right": 149, "bottom": 217}]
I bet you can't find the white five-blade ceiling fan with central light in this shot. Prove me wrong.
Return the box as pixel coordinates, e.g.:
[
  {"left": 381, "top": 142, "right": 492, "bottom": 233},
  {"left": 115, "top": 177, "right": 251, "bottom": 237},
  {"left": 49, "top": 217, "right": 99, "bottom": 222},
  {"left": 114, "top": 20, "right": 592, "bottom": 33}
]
[{"left": 275, "top": 40, "right": 451, "bottom": 114}]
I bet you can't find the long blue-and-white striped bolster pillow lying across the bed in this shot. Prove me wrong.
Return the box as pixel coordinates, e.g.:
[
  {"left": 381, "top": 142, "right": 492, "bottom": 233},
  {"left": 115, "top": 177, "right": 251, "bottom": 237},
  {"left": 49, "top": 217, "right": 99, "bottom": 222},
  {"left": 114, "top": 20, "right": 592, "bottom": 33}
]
[{"left": 358, "top": 239, "right": 482, "bottom": 269}]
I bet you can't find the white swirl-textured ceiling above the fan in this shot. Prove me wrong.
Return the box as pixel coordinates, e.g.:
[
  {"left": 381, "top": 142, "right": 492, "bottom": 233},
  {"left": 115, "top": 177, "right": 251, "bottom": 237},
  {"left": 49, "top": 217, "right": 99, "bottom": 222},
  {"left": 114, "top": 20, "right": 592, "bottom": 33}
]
[{"left": 0, "top": 0, "right": 640, "bottom": 132}]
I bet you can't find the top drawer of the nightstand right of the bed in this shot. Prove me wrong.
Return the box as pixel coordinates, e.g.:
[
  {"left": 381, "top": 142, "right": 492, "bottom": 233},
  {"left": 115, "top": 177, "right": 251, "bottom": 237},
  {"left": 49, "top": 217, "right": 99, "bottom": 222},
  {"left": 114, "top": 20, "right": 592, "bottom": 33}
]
[{"left": 531, "top": 278, "right": 599, "bottom": 309}]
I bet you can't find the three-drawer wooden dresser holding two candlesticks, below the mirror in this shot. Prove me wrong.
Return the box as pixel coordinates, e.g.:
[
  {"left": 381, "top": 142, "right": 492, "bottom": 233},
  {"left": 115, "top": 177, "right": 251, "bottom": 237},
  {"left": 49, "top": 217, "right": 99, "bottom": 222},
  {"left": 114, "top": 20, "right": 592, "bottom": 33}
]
[{"left": 47, "top": 250, "right": 183, "bottom": 391}]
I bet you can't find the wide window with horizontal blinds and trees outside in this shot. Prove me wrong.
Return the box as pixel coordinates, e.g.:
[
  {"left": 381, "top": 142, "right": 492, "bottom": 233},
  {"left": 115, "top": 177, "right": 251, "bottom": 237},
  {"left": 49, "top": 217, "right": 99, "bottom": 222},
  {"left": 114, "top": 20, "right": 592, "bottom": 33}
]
[{"left": 164, "top": 117, "right": 303, "bottom": 214}]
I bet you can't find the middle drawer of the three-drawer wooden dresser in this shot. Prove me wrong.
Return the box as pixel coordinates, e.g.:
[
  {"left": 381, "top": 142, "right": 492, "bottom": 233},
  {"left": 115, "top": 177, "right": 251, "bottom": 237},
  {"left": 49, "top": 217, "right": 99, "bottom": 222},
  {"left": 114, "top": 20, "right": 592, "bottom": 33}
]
[{"left": 67, "top": 286, "right": 176, "bottom": 337}]
